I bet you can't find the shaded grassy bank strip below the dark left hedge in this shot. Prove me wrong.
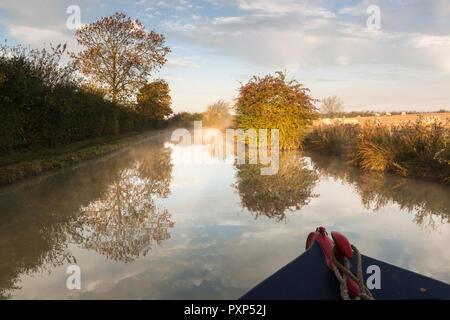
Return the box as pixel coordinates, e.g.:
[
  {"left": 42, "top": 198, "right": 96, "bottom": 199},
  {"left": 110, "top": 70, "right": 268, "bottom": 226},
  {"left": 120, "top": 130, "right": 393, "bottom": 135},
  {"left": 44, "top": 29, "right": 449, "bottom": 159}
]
[{"left": 0, "top": 131, "right": 165, "bottom": 185}]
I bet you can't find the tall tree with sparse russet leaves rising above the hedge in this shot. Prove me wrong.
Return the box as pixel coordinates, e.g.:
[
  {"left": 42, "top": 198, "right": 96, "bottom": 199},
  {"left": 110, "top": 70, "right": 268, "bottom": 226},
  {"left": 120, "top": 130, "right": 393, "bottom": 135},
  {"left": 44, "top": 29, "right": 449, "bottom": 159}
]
[{"left": 71, "top": 13, "right": 170, "bottom": 102}]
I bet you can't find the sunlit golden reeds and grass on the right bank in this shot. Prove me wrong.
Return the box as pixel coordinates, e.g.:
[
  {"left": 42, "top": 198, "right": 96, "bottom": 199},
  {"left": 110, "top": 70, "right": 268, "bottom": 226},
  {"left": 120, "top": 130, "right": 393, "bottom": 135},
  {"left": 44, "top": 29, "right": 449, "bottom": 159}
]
[{"left": 304, "top": 119, "right": 450, "bottom": 184}]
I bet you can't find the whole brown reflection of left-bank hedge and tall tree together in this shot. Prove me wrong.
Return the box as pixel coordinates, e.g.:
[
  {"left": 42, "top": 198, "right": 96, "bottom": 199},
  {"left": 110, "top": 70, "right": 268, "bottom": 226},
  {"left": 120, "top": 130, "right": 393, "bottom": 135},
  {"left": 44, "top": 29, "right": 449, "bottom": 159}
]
[{"left": 0, "top": 140, "right": 174, "bottom": 298}]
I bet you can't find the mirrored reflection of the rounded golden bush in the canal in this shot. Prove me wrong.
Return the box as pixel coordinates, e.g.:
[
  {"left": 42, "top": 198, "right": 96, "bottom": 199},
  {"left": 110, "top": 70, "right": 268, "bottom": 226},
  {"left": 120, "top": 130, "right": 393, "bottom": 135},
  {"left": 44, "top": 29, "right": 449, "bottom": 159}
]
[{"left": 235, "top": 151, "right": 318, "bottom": 222}]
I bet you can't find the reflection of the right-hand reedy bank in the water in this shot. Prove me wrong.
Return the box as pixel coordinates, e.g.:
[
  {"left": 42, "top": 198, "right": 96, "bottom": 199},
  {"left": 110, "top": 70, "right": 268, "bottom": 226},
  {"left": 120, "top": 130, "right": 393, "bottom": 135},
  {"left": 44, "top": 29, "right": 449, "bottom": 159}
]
[{"left": 309, "top": 154, "right": 450, "bottom": 231}]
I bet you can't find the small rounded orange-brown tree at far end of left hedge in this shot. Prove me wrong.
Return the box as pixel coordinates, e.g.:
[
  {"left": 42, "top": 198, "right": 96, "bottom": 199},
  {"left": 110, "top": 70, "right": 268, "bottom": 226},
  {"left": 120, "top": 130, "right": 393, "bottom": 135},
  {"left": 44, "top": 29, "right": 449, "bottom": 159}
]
[{"left": 136, "top": 79, "right": 173, "bottom": 120}]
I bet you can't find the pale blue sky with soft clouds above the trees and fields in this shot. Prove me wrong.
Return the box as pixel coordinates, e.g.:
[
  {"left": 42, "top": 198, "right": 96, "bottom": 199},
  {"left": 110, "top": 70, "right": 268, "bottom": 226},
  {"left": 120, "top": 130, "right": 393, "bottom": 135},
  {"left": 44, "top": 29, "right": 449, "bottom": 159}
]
[{"left": 0, "top": 0, "right": 450, "bottom": 112}]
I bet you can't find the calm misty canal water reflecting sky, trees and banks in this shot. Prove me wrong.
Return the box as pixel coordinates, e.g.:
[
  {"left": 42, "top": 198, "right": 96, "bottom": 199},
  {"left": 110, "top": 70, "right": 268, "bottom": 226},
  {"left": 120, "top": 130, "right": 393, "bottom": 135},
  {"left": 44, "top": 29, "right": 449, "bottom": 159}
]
[{"left": 0, "top": 129, "right": 450, "bottom": 299}]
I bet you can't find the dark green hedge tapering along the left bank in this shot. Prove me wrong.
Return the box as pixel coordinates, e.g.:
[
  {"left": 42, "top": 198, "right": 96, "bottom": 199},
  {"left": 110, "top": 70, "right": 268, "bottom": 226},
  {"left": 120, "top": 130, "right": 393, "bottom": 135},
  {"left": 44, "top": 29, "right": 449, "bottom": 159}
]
[{"left": 0, "top": 46, "right": 166, "bottom": 153}]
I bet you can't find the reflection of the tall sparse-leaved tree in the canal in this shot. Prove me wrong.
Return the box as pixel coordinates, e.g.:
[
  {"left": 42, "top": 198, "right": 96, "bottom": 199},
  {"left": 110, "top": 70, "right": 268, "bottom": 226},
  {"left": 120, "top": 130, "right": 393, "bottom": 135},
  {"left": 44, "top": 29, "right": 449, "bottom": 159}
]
[{"left": 79, "top": 148, "right": 174, "bottom": 263}]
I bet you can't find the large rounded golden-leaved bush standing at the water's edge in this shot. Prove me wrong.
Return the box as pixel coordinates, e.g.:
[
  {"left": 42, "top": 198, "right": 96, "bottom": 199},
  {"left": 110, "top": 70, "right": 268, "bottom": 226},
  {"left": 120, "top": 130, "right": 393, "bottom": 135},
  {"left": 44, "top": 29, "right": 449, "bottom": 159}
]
[{"left": 235, "top": 72, "right": 316, "bottom": 149}]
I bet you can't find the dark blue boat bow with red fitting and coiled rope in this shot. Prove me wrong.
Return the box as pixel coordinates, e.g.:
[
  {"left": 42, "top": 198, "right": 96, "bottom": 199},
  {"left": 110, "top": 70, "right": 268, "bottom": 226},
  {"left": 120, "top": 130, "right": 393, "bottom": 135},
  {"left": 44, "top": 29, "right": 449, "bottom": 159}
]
[{"left": 241, "top": 227, "right": 450, "bottom": 300}]
